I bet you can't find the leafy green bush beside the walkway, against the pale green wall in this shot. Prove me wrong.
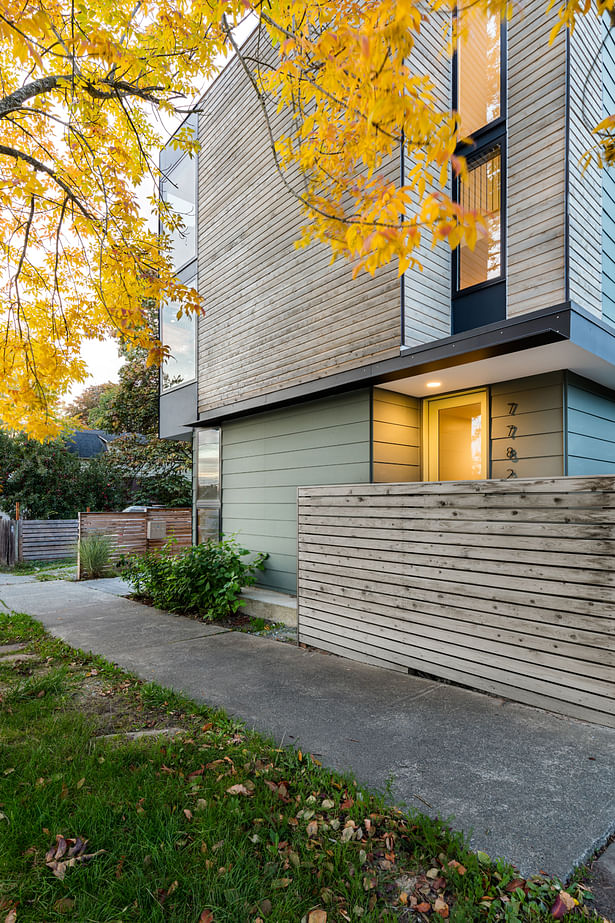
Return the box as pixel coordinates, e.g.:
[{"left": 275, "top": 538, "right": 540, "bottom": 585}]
[{"left": 123, "top": 538, "right": 267, "bottom": 619}]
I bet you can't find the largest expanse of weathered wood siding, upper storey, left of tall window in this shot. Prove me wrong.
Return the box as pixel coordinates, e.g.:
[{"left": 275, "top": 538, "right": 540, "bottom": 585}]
[{"left": 198, "top": 30, "right": 401, "bottom": 412}]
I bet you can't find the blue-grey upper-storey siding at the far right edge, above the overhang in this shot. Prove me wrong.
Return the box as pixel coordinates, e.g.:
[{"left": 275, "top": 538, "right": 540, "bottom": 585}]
[{"left": 602, "top": 25, "right": 615, "bottom": 324}]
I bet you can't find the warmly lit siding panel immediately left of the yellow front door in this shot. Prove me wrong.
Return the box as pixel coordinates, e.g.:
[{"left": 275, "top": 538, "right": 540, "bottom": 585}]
[{"left": 372, "top": 388, "right": 421, "bottom": 483}]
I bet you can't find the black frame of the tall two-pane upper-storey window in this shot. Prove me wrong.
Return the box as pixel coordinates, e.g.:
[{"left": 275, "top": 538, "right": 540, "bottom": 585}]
[{"left": 451, "top": 13, "right": 508, "bottom": 302}]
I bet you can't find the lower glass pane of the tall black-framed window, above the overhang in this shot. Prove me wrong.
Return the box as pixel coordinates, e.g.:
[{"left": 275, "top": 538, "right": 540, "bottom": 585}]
[{"left": 459, "top": 146, "right": 502, "bottom": 289}]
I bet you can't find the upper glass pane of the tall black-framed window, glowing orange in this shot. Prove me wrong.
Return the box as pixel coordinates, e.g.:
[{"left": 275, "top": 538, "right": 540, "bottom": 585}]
[{"left": 457, "top": 8, "right": 501, "bottom": 137}]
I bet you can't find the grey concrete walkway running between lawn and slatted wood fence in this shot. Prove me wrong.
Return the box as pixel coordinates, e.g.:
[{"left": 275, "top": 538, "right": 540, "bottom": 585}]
[{"left": 0, "top": 580, "right": 615, "bottom": 878}]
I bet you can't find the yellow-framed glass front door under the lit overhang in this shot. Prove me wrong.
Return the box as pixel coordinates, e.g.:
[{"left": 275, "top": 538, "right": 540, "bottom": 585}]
[{"left": 423, "top": 389, "right": 489, "bottom": 481}]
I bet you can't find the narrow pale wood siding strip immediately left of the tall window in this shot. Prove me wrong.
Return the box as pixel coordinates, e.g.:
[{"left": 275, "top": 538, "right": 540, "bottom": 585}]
[{"left": 404, "top": 12, "right": 452, "bottom": 346}]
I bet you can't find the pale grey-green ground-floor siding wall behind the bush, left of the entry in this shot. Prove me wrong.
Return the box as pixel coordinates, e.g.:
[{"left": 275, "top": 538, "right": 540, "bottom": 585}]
[{"left": 222, "top": 389, "right": 370, "bottom": 593}]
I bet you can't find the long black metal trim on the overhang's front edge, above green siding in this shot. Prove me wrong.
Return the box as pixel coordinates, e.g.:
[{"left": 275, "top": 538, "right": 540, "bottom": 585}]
[{"left": 185, "top": 303, "right": 572, "bottom": 426}]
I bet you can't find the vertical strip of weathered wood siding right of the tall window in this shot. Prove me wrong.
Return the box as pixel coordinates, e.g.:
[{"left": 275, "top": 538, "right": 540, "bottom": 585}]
[{"left": 506, "top": 0, "right": 566, "bottom": 317}]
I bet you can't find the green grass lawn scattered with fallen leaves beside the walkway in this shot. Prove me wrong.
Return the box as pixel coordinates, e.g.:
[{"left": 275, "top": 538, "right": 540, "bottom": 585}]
[{"left": 0, "top": 614, "right": 591, "bottom": 923}]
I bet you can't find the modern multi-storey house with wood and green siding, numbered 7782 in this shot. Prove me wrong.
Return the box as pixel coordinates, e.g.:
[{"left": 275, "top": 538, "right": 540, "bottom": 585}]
[{"left": 160, "top": 7, "right": 615, "bottom": 593}]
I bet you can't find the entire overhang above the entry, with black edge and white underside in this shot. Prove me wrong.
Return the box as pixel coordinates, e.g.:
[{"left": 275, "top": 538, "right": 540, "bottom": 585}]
[{"left": 187, "top": 302, "right": 615, "bottom": 426}]
